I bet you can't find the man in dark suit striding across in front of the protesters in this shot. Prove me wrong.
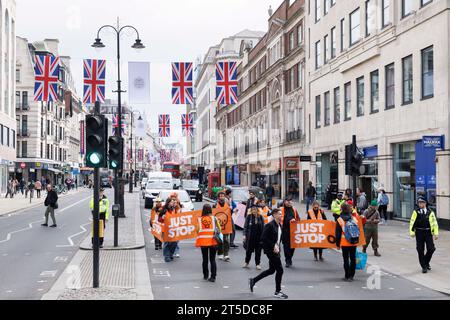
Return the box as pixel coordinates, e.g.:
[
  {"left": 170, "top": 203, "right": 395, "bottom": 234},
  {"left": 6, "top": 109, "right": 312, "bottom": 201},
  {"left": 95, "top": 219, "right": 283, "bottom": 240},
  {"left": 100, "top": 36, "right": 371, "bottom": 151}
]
[{"left": 249, "top": 208, "right": 288, "bottom": 299}]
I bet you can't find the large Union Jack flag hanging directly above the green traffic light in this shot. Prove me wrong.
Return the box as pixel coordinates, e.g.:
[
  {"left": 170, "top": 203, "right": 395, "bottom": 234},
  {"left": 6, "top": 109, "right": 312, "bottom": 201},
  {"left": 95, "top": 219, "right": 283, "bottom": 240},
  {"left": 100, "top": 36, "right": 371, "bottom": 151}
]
[{"left": 83, "top": 59, "right": 106, "bottom": 104}]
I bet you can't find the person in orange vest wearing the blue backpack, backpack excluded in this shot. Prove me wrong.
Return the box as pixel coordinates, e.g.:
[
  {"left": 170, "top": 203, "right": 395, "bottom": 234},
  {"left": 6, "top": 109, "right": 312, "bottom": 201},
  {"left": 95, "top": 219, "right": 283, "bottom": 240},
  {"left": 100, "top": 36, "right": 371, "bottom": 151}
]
[{"left": 336, "top": 203, "right": 359, "bottom": 281}]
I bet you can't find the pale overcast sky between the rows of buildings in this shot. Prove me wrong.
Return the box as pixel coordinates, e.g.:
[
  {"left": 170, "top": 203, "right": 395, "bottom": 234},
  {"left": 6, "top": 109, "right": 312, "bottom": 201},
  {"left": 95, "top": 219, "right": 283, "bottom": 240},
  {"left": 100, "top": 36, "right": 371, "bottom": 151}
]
[{"left": 16, "top": 0, "right": 282, "bottom": 148}]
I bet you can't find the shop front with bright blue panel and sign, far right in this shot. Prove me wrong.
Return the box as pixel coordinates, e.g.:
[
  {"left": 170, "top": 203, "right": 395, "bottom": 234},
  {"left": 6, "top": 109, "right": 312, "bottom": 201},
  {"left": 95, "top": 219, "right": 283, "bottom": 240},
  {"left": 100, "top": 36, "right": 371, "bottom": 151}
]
[{"left": 393, "top": 136, "right": 444, "bottom": 219}]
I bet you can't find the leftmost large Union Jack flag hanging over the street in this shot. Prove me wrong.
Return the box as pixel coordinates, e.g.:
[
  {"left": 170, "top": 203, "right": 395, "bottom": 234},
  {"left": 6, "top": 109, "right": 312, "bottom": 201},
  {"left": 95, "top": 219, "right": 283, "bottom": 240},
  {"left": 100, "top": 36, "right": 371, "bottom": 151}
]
[{"left": 34, "top": 54, "right": 59, "bottom": 102}]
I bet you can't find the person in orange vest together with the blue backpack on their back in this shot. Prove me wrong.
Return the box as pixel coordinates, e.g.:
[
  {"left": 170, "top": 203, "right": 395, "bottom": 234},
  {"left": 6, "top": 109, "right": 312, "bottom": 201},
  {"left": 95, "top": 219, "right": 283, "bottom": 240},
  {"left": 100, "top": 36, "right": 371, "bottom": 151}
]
[{"left": 336, "top": 203, "right": 359, "bottom": 282}]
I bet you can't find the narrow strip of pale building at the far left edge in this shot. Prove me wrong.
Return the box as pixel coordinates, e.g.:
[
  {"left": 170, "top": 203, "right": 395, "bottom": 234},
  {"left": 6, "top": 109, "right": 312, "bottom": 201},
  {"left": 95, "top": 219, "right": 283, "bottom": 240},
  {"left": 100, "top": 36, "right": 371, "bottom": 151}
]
[{"left": 0, "top": 0, "right": 17, "bottom": 194}]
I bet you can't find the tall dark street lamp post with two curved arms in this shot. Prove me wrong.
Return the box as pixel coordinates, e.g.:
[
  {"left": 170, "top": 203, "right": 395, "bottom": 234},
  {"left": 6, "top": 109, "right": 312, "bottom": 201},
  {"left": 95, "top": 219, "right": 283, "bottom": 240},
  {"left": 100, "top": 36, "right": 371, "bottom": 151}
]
[{"left": 92, "top": 19, "right": 145, "bottom": 218}]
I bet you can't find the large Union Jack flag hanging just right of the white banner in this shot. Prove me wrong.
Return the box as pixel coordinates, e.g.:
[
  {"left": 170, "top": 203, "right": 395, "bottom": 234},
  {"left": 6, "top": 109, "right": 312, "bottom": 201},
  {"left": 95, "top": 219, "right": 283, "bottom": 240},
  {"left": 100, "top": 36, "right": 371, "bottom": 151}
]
[{"left": 172, "top": 62, "right": 194, "bottom": 104}]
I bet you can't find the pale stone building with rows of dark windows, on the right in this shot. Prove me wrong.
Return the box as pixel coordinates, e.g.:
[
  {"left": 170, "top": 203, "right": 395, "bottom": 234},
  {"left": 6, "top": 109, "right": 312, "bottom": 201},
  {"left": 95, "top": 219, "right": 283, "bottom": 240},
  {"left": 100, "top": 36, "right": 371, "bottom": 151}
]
[{"left": 306, "top": 0, "right": 450, "bottom": 224}]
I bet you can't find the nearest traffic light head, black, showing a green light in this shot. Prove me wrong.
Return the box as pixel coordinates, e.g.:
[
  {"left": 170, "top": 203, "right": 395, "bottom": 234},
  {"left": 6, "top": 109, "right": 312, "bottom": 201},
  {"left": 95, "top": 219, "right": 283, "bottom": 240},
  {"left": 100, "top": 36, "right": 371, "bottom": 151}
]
[{"left": 86, "top": 115, "right": 108, "bottom": 168}]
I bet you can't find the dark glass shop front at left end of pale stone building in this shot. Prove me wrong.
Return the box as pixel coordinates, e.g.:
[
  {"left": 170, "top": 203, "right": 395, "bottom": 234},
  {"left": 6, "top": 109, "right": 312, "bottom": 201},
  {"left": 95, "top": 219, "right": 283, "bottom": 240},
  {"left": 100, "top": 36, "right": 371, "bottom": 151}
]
[{"left": 316, "top": 151, "right": 339, "bottom": 206}]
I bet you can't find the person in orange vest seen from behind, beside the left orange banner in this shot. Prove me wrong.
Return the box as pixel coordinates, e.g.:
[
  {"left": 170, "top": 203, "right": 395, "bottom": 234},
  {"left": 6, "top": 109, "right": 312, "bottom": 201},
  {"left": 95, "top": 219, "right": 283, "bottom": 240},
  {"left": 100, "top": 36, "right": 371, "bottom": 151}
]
[{"left": 195, "top": 204, "right": 220, "bottom": 282}]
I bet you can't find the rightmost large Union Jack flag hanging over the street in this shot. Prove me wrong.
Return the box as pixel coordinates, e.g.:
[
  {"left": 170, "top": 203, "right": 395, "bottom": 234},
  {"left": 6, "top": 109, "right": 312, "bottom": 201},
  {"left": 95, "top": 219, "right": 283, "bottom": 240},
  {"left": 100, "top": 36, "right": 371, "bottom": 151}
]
[{"left": 216, "top": 61, "right": 238, "bottom": 105}]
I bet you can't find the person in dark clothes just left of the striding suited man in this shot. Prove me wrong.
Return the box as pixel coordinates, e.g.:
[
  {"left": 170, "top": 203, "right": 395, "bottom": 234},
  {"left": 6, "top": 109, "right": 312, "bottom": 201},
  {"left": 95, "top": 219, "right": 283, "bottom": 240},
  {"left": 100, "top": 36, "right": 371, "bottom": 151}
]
[{"left": 243, "top": 207, "right": 264, "bottom": 270}]
